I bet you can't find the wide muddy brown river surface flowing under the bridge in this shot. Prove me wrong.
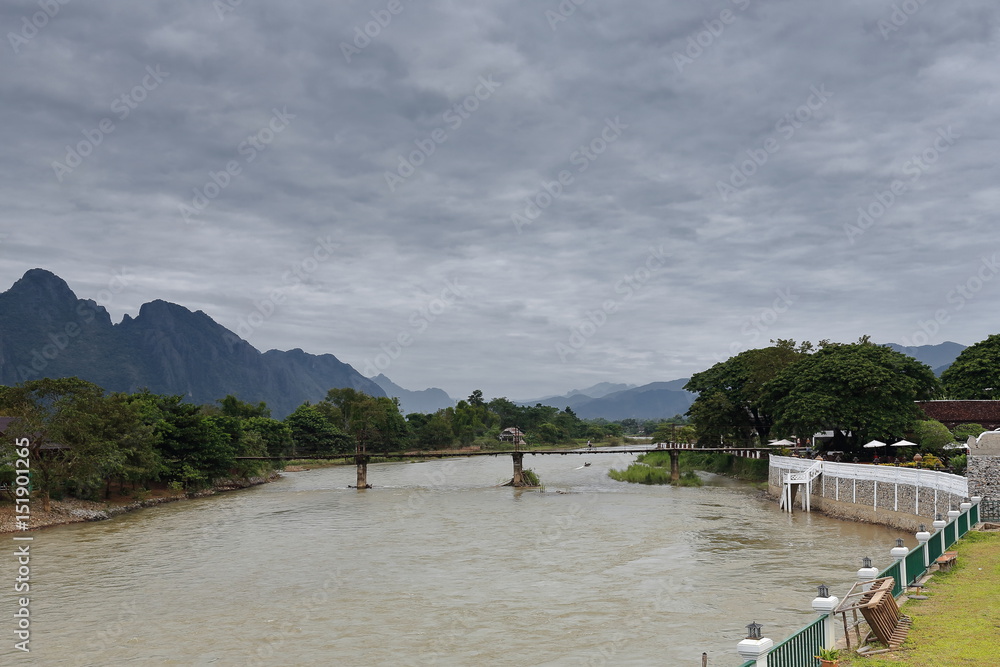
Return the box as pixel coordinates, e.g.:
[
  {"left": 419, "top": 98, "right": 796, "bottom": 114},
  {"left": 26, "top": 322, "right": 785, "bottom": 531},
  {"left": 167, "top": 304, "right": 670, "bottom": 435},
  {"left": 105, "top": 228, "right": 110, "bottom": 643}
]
[{"left": 0, "top": 454, "right": 896, "bottom": 667}]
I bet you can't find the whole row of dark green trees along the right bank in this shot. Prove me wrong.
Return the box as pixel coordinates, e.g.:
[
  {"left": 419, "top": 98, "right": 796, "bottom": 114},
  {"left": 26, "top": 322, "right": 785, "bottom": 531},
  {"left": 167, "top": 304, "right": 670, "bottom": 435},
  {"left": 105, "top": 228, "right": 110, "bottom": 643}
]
[{"left": 684, "top": 335, "right": 1000, "bottom": 452}]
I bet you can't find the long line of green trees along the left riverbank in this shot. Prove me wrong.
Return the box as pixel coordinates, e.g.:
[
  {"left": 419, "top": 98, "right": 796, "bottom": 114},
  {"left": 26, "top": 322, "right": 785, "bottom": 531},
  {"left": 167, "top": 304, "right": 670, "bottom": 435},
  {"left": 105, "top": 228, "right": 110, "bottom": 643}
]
[{"left": 0, "top": 378, "right": 683, "bottom": 510}]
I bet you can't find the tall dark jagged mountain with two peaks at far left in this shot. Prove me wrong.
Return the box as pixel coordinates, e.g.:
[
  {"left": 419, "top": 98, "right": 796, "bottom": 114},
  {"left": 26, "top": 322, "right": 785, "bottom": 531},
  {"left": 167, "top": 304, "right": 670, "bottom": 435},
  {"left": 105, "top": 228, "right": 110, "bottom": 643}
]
[{"left": 0, "top": 269, "right": 385, "bottom": 419}]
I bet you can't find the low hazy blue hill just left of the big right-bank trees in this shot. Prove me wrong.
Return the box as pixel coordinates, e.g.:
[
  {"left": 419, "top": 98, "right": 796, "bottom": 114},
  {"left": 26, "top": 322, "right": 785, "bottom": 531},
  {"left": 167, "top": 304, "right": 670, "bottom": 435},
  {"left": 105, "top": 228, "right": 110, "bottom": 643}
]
[{"left": 529, "top": 378, "right": 695, "bottom": 421}]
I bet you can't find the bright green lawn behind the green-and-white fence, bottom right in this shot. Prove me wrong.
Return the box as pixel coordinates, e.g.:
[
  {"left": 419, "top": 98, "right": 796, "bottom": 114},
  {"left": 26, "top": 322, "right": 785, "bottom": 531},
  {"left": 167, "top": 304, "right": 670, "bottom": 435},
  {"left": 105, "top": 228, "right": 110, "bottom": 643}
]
[{"left": 841, "top": 532, "right": 1000, "bottom": 667}]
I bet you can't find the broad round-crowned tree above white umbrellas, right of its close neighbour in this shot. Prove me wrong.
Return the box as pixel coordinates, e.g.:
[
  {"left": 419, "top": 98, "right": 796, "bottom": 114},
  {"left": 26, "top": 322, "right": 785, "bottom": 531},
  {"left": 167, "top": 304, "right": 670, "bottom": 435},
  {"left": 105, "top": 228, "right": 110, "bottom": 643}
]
[{"left": 765, "top": 336, "right": 940, "bottom": 449}]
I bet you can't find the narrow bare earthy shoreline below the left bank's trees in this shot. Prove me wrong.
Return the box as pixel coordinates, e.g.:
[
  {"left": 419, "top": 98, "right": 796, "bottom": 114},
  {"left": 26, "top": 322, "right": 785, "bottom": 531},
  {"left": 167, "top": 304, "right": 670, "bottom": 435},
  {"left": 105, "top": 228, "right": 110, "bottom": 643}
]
[{"left": 0, "top": 473, "right": 280, "bottom": 533}]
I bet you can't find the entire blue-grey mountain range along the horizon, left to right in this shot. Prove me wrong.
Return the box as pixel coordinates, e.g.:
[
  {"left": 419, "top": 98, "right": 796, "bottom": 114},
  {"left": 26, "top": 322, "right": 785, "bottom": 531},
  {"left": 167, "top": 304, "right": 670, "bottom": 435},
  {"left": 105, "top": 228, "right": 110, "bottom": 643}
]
[{"left": 0, "top": 269, "right": 965, "bottom": 420}]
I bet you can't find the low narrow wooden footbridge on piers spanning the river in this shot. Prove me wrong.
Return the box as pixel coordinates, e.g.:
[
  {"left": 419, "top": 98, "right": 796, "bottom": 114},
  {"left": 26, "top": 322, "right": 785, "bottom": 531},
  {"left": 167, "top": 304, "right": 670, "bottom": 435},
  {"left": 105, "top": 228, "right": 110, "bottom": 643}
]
[{"left": 236, "top": 442, "right": 772, "bottom": 490}]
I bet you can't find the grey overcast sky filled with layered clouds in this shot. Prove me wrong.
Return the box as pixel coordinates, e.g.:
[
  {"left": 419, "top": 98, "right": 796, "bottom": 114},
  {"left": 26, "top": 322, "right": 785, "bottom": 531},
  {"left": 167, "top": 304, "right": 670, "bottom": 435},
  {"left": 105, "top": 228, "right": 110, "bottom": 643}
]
[{"left": 0, "top": 0, "right": 1000, "bottom": 398}]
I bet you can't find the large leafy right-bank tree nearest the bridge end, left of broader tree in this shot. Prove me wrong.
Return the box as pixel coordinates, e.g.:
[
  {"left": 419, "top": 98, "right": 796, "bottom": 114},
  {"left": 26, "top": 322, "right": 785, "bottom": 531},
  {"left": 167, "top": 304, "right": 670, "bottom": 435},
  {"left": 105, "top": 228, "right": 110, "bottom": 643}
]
[{"left": 684, "top": 340, "right": 812, "bottom": 444}]
